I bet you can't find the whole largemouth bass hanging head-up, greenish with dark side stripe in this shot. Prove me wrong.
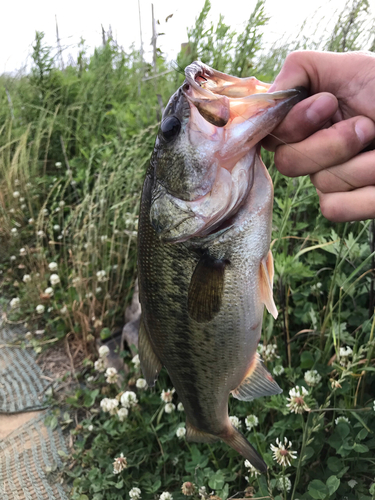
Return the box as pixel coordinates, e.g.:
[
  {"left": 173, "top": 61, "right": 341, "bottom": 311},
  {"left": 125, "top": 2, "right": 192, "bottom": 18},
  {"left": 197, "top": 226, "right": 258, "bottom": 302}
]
[{"left": 138, "top": 61, "right": 306, "bottom": 472}]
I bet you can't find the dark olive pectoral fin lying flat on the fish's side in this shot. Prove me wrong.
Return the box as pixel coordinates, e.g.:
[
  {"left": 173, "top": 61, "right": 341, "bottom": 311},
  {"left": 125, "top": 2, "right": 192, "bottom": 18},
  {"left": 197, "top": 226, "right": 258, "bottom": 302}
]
[{"left": 188, "top": 255, "right": 227, "bottom": 323}]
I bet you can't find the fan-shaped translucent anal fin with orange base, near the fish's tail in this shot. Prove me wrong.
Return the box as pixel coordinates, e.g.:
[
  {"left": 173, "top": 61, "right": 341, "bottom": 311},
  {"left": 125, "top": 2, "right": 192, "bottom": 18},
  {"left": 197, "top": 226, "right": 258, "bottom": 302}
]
[{"left": 232, "top": 354, "right": 283, "bottom": 401}]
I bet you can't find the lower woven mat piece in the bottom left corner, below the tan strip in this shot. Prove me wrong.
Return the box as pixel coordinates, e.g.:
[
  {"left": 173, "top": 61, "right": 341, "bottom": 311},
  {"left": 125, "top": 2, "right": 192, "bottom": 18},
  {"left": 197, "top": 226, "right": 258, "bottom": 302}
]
[{"left": 0, "top": 412, "right": 68, "bottom": 500}]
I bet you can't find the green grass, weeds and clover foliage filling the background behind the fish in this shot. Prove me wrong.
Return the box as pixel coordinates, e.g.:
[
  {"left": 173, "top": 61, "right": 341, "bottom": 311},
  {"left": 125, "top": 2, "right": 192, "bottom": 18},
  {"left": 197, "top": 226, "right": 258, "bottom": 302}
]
[{"left": 0, "top": 0, "right": 375, "bottom": 500}]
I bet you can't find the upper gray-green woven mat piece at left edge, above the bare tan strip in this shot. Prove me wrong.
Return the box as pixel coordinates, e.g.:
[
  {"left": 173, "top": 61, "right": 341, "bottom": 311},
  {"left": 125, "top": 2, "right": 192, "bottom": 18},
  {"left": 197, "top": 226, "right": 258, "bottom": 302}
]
[{"left": 0, "top": 316, "right": 48, "bottom": 413}]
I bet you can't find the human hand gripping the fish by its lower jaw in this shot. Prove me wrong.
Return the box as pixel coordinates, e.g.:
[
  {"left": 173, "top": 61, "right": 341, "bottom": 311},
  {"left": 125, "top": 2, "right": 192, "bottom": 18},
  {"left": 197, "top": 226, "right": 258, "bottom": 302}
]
[{"left": 262, "top": 51, "right": 375, "bottom": 222}]
